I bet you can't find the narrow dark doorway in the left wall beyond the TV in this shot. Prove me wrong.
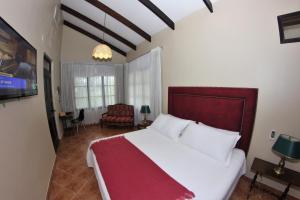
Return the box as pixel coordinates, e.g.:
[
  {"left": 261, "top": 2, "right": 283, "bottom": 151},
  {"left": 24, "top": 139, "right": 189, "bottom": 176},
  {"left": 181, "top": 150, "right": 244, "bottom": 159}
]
[{"left": 44, "top": 55, "right": 59, "bottom": 152}]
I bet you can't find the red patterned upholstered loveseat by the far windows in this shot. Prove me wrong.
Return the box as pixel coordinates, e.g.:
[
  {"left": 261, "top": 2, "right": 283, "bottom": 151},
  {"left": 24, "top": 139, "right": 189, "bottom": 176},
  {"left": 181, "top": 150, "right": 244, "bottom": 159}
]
[{"left": 100, "top": 104, "right": 134, "bottom": 127}]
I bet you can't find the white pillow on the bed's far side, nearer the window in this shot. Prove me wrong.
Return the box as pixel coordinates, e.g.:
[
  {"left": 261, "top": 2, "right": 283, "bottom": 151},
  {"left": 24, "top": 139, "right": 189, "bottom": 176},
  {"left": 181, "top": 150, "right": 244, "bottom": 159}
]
[{"left": 149, "top": 114, "right": 192, "bottom": 141}]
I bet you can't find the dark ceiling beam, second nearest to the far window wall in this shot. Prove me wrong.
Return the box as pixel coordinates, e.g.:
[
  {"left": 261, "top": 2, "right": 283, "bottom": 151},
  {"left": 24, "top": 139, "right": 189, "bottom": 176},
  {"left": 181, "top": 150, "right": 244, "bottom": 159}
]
[{"left": 61, "top": 4, "right": 136, "bottom": 50}]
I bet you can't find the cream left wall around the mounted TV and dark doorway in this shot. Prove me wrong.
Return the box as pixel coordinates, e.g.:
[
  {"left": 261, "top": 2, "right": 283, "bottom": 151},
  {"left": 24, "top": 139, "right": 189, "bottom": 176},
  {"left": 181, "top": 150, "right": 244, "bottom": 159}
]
[{"left": 0, "top": 0, "right": 61, "bottom": 200}]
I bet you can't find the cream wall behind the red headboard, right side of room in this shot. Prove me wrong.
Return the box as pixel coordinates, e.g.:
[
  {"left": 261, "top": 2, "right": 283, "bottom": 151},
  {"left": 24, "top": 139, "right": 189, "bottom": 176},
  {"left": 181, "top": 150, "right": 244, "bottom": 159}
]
[{"left": 127, "top": 0, "right": 300, "bottom": 198}]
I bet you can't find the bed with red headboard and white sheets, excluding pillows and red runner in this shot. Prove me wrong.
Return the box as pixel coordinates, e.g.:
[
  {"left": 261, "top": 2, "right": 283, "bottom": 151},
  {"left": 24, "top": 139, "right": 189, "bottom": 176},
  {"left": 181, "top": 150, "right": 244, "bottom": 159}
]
[{"left": 87, "top": 87, "right": 258, "bottom": 200}]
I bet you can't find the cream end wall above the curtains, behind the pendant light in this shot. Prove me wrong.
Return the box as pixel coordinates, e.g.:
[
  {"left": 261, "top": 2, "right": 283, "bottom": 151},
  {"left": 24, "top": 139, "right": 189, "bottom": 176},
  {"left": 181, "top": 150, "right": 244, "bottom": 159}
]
[{"left": 61, "top": 26, "right": 126, "bottom": 64}]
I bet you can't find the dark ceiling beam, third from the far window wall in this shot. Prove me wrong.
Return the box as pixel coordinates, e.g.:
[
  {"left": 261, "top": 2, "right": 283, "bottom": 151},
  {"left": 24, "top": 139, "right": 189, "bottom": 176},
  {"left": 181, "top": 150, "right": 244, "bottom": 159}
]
[{"left": 86, "top": 0, "right": 151, "bottom": 42}]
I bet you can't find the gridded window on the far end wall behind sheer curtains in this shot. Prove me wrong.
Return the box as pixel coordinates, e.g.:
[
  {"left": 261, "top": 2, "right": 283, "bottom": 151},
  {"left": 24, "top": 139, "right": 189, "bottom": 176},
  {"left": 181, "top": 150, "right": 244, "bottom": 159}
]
[{"left": 74, "top": 76, "right": 116, "bottom": 109}]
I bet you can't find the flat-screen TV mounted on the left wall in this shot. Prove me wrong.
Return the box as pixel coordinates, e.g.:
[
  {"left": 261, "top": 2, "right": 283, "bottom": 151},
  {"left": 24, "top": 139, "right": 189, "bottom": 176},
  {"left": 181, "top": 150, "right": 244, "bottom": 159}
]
[{"left": 0, "top": 17, "right": 38, "bottom": 100}]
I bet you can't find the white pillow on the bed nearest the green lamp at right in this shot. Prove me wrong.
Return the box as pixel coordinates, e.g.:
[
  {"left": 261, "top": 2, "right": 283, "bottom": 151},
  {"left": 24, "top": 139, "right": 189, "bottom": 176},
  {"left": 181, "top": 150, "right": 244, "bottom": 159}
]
[{"left": 180, "top": 124, "right": 240, "bottom": 166}]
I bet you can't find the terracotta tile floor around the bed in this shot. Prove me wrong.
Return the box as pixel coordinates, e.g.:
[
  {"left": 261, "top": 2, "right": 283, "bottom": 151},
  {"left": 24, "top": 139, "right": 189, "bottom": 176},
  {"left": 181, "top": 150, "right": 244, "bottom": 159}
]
[{"left": 47, "top": 126, "right": 295, "bottom": 200}]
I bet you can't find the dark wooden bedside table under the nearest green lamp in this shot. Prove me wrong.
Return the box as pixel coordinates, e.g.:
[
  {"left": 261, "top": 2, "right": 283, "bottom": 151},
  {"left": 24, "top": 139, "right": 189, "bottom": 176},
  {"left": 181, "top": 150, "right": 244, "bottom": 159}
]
[{"left": 247, "top": 158, "right": 300, "bottom": 200}]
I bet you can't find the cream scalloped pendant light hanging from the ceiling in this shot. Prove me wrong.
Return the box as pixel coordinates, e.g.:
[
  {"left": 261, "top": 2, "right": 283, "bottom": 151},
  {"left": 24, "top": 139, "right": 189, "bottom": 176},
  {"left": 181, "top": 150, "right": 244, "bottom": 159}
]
[{"left": 92, "top": 13, "right": 112, "bottom": 61}]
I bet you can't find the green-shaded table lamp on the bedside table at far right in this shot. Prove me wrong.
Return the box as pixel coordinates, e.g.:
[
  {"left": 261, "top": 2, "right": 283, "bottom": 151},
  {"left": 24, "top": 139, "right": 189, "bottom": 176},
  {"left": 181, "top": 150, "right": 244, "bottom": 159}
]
[{"left": 272, "top": 134, "right": 300, "bottom": 175}]
